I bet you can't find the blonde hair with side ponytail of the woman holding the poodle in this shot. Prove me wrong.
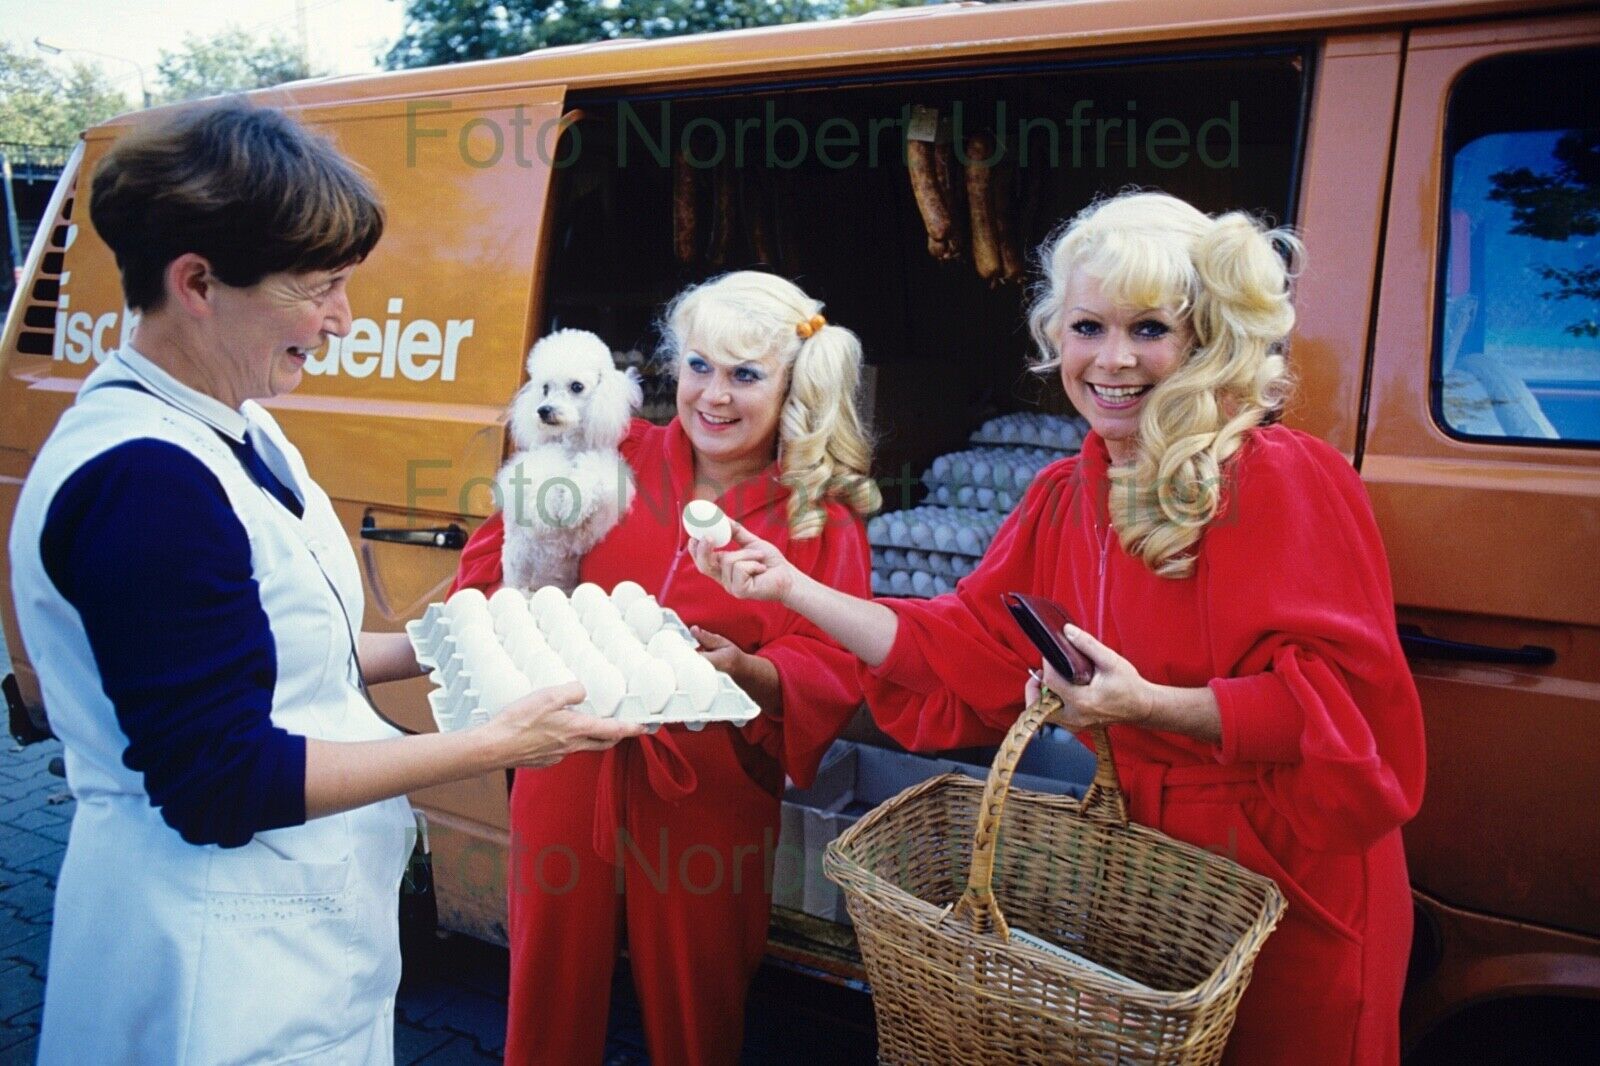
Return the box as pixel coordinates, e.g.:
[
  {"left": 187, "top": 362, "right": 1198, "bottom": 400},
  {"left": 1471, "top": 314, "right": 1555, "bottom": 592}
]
[{"left": 661, "top": 271, "right": 883, "bottom": 539}]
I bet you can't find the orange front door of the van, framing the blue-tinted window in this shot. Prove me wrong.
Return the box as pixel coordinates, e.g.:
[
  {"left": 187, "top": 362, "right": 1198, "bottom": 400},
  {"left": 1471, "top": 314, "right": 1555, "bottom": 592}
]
[{"left": 1362, "top": 18, "right": 1600, "bottom": 951}]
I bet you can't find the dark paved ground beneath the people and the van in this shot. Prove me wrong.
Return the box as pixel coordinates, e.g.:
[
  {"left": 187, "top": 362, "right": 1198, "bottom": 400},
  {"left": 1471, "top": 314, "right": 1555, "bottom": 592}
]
[{"left": 0, "top": 738, "right": 875, "bottom": 1066}]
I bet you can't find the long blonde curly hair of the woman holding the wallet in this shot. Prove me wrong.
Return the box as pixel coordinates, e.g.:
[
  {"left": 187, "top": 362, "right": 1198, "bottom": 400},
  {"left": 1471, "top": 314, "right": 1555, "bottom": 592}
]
[{"left": 1027, "top": 192, "right": 1304, "bottom": 578}]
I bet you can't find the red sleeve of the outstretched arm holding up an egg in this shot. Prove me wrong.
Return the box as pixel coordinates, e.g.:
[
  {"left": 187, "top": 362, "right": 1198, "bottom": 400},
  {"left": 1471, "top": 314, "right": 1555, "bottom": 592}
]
[{"left": 861, "top": 461, "right": 1074, "bottom": 751}]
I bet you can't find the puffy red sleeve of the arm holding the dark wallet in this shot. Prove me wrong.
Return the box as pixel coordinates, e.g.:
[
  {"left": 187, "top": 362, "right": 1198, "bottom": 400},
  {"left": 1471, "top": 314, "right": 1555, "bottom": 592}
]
[{"left": 1197, "top": 429, "right": 1424, "bottom": 852}]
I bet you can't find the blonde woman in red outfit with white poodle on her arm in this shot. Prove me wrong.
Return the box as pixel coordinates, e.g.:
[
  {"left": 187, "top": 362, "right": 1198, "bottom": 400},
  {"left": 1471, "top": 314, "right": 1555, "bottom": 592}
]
[{"left": 456, "top": 271, "right": 878, "bottom": 1066}]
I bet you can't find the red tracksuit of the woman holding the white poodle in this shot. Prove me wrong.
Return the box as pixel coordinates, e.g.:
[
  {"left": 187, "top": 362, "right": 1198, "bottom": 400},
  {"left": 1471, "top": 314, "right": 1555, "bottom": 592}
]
[{"left": 453, "top": 421, "right": 870, "bottom": 1066}]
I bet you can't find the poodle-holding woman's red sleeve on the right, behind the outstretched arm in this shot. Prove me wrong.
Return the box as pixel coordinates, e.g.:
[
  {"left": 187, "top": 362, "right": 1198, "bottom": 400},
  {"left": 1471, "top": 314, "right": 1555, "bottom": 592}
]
[{"left": 746, "top": 504, "right": 872, "bottom": 787}]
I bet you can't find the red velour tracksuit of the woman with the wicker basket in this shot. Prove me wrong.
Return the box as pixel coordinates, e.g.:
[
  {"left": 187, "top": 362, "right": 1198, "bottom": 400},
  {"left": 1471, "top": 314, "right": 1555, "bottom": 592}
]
[{"left": 862, "top": 426, "right": 1424, "bottom": 1066}]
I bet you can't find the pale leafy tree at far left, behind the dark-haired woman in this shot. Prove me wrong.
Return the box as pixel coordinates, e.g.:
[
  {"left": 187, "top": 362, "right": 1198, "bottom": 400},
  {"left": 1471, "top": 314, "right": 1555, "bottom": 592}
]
[{"left": 0, "top": 42, "right": 130, "bottom": 144}]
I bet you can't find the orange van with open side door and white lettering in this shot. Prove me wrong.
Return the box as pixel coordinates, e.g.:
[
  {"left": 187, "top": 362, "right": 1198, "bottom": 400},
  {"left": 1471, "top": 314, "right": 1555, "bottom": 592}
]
[{"left": 0, "top": 0, "right": 1600, "bottom": 1060}]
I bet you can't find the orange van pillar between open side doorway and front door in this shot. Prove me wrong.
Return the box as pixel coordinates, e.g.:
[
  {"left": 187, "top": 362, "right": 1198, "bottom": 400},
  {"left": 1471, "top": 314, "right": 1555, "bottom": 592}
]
[{"left": 1285, "top": 32, "right": 1402, "bottom": 456}]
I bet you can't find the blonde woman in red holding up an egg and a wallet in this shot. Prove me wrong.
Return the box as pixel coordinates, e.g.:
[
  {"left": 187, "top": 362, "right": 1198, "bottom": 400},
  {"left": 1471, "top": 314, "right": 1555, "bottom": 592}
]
[{"left": 696, "top": 194, "right": 1424, "bottom": 1066}]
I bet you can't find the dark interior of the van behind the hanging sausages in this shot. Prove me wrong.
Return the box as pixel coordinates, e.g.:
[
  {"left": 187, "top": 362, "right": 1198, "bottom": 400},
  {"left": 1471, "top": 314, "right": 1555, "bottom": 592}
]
[{"left": 542, "top": 45, "right": 1309, "bottom": 480}]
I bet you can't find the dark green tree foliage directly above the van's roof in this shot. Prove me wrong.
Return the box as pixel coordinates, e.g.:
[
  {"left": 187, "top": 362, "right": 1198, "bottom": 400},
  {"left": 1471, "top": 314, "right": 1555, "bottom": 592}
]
[{"left": 382, "top": 0, "right": 938, "bottom": 70}]
